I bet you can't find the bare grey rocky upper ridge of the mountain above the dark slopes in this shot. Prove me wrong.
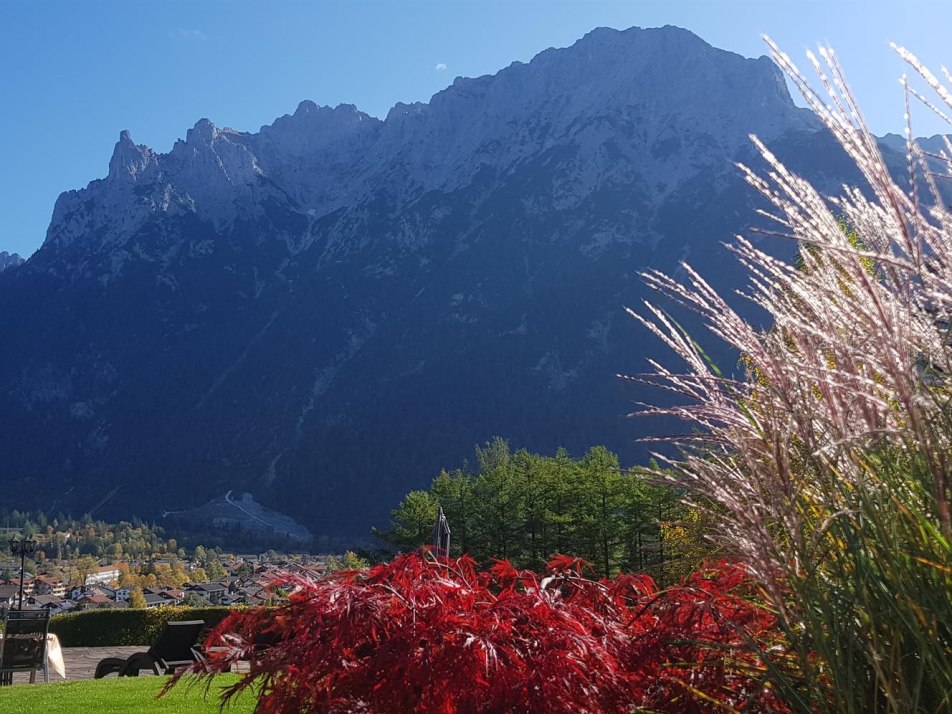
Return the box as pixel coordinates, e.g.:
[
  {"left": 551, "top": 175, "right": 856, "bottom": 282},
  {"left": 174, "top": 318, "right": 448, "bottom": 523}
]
[{"left": 47, "top": 27, "right": 816, "bottom": 262}]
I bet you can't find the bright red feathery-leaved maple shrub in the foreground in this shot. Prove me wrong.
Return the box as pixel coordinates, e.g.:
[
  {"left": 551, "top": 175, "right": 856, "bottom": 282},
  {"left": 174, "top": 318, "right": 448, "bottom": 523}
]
[{"left": 175, "top": 552, "right": 786, "bottom": 714}]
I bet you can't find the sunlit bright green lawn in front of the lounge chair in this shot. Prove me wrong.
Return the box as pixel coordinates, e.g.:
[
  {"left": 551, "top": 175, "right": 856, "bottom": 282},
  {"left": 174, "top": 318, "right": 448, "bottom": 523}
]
[{"left": 0, "top": 674, "right": 255, "bottom": 714}]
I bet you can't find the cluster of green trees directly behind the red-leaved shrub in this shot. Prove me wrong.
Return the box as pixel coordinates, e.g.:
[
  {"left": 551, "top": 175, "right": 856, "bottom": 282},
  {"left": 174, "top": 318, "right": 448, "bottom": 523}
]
[{"left": 376, "top": 437, "right": 705, "bottom": 582}]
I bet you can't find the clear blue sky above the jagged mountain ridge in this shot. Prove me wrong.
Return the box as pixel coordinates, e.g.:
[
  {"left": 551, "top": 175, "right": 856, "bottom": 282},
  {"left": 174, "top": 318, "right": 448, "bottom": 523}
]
[{"left": 0, "top": 0, "right": 952, "bottom": 256}]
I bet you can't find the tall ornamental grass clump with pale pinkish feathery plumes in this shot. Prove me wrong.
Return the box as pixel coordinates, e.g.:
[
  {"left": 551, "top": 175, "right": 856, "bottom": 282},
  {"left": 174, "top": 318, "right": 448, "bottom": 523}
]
[{"left": 631, "top": 39, "right": 952, "bottom": 713}]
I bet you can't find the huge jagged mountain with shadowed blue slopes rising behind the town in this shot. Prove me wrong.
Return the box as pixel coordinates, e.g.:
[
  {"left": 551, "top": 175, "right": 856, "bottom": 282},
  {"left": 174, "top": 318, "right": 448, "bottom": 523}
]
[{"left": 0, "top": 27, "right": 880, "bottom": 537}]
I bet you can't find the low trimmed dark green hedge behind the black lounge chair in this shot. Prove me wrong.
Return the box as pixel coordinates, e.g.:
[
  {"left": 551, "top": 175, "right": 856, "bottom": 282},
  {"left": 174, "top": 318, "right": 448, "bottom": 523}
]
[{"left": 50, "top": 606, "right": 242, "bottom": 647}]
